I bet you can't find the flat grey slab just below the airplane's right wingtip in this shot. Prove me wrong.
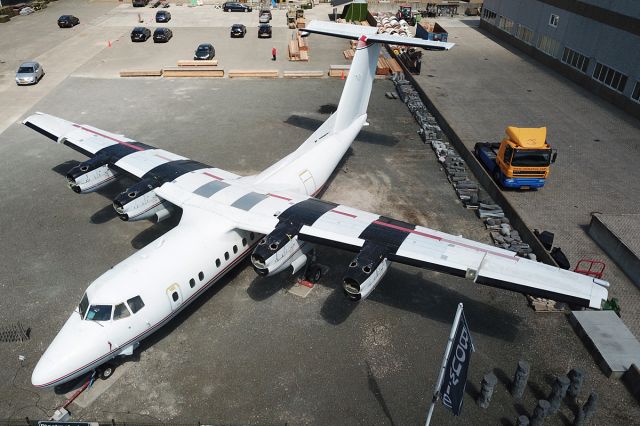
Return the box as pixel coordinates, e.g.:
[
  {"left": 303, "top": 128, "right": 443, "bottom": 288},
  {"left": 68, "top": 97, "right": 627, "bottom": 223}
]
[{"left": 569, "top": 311, "right": 640, "bottom": 378}]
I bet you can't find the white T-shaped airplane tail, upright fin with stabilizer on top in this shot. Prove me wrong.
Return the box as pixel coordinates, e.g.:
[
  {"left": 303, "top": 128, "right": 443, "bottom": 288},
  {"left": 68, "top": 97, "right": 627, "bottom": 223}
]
[{"left": 300, "top": 21, "right": 454, "bottom": 132}]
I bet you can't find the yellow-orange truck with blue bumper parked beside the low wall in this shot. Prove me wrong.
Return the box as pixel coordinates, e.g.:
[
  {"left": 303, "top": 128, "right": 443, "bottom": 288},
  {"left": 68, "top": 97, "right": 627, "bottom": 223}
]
[{"left": 474, "top": 126, "right": 557, "bottom": 189}]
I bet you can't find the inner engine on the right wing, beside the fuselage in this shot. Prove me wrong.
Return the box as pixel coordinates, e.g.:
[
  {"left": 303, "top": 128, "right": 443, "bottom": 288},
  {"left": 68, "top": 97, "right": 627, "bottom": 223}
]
[{"left": 251, "top": 221, "right": 313, "bottom": 276}]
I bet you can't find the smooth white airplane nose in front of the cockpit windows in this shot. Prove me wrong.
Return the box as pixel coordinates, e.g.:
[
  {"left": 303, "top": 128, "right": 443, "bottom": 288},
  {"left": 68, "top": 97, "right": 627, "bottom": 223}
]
[{"left": 31, "top": 312, "right": 111, "bottom": 388}]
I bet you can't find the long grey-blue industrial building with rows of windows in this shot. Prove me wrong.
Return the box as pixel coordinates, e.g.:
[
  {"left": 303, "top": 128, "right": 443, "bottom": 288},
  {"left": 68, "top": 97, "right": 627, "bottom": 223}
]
[{"left": 480, "top": 0, "right": 640, "bottom": 118}]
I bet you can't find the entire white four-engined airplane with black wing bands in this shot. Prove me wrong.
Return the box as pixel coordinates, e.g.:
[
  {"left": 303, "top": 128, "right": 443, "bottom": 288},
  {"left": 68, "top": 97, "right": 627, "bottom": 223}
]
[{"left": 23, "top": 22, "right": 608, "bottom": 388}]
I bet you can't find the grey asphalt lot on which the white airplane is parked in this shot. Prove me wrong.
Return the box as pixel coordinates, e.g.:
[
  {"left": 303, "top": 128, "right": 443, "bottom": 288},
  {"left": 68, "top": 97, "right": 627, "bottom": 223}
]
[{"left": 0, "top": 0, "right": 640, "bottom": 425}]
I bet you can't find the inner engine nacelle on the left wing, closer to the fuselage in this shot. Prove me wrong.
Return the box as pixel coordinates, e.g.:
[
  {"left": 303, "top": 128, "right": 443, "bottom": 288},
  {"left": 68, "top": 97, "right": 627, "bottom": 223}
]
[{"left": 113, "top": 179, "right": 171, "bottom": 222}]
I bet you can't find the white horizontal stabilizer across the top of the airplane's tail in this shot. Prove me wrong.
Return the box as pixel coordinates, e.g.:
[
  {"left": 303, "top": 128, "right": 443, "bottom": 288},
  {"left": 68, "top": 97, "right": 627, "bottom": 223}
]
[{"left": 300, "top": 21, "right": 455, "bottom": 50}]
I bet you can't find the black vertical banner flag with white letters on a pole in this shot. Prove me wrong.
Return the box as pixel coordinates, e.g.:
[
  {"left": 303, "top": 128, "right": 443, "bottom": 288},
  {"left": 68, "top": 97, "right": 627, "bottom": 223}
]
[{"left": 440, "top": 311, "right": 473, "bottom": 416}]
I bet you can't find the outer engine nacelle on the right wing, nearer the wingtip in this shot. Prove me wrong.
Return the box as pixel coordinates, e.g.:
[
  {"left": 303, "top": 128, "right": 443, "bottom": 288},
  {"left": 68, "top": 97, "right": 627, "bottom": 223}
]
[{"left": 342, "top": 243, "right": 391, "bottom": 300}]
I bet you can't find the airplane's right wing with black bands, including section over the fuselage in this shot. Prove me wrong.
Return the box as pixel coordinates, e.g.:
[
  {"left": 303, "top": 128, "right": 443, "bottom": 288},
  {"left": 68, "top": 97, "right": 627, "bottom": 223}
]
[{"left": 157, "top": 182, "right": 608, "bottom": 309}]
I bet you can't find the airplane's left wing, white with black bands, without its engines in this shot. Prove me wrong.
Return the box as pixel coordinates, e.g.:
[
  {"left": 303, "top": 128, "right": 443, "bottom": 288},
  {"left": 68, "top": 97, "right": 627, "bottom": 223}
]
[{"left": 22, "top": 112, "right": 239, "bottom": 179}]
